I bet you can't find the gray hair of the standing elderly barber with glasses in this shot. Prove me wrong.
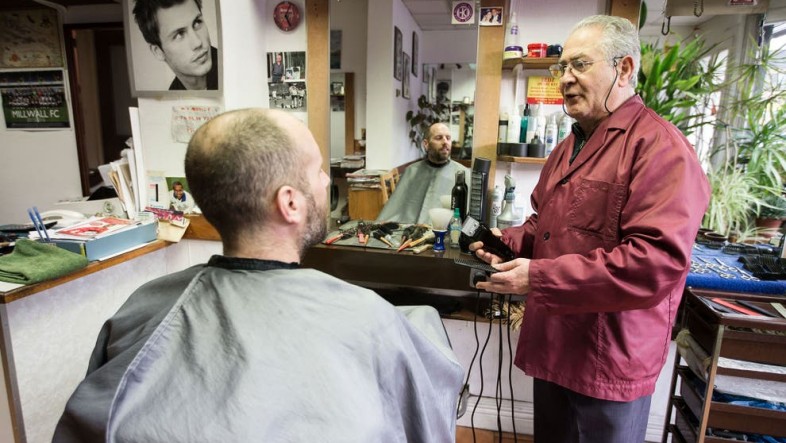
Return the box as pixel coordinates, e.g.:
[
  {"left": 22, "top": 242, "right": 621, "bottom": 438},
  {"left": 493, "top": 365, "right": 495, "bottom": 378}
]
[{"left": 570, "top": 15, "right": 641, "bottom": 81}]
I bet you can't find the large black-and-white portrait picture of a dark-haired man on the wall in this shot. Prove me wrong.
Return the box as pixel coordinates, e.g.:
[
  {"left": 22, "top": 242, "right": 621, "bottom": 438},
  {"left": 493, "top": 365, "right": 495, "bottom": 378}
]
[{"left": 123, "top": 0, "right": 222, "bottom": 97}]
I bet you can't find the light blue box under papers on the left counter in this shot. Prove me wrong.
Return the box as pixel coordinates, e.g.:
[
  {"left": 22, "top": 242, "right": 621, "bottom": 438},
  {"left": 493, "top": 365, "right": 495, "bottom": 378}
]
[{"left": 53, "top": 223, "right": 158, "bottom": 261}]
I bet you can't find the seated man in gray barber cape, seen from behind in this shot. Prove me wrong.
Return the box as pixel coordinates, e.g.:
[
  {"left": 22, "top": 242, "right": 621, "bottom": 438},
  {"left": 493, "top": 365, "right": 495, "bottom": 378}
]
[{"left": 54, "top": 109, "right": 463, "bottom": 442}]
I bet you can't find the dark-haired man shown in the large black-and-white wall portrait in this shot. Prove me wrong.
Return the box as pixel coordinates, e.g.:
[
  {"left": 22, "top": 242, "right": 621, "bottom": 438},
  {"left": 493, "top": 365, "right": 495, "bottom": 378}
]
[{"left": 134, "top": 0, "right": 218, "bottom": 91}]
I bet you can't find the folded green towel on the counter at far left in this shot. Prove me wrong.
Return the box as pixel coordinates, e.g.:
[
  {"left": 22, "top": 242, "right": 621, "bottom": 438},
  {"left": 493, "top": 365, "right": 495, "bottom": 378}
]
[{"left": 0, "top": 239, "right": 87, "bottom": 285}]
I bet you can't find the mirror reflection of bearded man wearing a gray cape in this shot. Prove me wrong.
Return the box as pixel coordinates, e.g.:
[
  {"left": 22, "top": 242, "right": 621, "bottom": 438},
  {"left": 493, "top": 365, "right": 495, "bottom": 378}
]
[{"left": 377, "top": 123, "right": 469, "bottom": 223}]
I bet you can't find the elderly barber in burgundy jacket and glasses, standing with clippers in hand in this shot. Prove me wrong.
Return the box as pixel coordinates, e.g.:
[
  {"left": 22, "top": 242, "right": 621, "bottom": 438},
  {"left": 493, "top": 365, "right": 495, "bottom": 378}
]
[{"left": 470, "top": 16, "right": 710, "bottom": 443}]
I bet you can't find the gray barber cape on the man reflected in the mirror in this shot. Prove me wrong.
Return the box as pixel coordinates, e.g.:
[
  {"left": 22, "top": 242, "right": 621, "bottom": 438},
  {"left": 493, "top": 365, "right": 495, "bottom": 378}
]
[{"left": 377, "top": 159, "right": 470, "bottom": 223}]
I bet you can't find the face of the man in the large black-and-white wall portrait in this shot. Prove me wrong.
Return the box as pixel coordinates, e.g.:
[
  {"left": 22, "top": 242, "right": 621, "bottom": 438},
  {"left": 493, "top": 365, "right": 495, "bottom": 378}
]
[{"left": 150, "top": 0, "right": 213, "bottom": 89}]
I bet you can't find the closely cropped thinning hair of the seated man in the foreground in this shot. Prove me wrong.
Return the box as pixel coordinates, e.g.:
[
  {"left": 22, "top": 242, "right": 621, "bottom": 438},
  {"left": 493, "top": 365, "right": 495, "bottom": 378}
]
[{"left": 185, "top": 109, "right": 308, "bottom": 240}]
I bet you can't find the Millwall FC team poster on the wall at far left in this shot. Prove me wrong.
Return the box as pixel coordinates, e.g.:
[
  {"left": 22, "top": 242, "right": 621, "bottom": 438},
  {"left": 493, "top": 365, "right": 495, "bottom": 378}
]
[{"left": 0, "top": 69, "right": 71, "bottom": 129}]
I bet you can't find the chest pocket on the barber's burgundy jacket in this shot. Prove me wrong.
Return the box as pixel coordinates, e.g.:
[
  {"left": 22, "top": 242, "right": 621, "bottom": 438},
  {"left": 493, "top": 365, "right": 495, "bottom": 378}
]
[{"left": 568, "top": 178, "right": 626, "bottom": 242}]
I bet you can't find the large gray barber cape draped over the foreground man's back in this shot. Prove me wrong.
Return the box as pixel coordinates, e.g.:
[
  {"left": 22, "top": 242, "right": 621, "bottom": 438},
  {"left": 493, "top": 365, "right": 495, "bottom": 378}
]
[{"left": 53, "top": 256, "right": 464, "bottom": 443}]
